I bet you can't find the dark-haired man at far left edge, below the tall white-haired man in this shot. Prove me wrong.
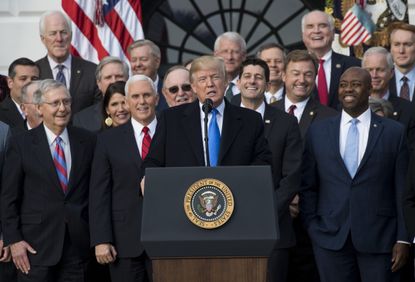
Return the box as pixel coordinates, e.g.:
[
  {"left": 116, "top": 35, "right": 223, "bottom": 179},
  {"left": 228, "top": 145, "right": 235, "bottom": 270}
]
[{"left": 0, "top": 58, "right": 39, "bottom": 129}]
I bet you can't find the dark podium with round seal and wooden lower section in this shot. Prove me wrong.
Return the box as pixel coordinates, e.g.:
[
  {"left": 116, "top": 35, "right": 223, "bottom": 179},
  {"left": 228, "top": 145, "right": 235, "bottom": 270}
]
[{"left": 141, "top": 166, "right": 279, "bottom": 282}]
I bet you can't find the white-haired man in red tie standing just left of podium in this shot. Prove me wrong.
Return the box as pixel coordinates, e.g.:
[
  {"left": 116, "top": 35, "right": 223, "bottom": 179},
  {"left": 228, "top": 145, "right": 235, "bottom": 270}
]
[{"left": 89, "top": 75, "right": 158, "bottom": 282}]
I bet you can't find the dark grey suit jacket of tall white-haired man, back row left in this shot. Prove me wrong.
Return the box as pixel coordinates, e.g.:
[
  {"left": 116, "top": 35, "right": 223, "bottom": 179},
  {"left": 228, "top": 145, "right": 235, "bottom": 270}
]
[{"left": 36, "top": 56, "right": 102, "bottom": 114}]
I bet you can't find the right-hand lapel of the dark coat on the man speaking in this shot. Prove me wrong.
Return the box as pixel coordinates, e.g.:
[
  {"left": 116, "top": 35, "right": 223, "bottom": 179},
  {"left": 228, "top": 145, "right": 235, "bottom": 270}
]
[{"left": 218, "top": 100, "right": 242, "bottom": 164}]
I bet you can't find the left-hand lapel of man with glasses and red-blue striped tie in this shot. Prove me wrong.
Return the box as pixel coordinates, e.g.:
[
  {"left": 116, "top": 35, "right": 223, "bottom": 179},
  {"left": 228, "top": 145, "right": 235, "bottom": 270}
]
[{"left": 32, "top": 124, "right": 65, "bottom": 196}]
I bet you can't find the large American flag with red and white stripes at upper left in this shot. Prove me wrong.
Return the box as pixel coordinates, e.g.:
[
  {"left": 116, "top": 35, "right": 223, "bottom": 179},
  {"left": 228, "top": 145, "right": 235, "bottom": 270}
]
[{"left": 62, "top": 0, "right": 144, "bottom": 63}]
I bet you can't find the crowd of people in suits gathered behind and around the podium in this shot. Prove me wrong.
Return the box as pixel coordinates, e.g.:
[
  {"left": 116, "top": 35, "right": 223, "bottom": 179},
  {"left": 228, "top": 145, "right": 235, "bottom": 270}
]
[{"left": 0, "top": 7, "right": 415, "bottom": 282}]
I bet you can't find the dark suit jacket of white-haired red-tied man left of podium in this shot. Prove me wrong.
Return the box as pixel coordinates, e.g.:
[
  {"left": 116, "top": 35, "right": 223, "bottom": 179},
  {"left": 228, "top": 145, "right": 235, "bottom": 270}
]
[{"left": 89, "top": 122, "right": 143, "bottom": 258}]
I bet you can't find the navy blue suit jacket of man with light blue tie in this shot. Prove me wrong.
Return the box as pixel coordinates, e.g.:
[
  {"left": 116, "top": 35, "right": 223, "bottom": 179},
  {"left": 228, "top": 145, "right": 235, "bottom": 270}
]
[{"left": 300, "top": 113, "right": 408, "bottom": 253}]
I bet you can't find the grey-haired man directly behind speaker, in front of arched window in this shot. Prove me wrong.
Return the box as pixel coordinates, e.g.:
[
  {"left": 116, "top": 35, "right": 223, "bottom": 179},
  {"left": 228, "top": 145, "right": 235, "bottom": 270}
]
[{"left": 214, "top": 31, "right": 246, "bottom": 102}]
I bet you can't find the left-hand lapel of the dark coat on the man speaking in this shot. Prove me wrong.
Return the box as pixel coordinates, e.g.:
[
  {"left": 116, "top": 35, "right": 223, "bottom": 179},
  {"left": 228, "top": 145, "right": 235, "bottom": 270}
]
[{"left": 181, "top": 100, "right": 205, "bottom": 166}]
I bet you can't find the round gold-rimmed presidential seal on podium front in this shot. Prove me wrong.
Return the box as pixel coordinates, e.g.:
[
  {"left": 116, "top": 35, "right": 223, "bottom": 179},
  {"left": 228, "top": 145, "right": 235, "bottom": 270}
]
[{"left": 184, "top": 178, "right": 235, "bottom": 229}]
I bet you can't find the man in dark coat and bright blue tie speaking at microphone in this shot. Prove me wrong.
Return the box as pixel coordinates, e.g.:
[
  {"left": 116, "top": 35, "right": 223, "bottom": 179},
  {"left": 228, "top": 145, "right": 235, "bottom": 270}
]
[{"left": 144, "top": 56, "right": 271, "bottom": 174}]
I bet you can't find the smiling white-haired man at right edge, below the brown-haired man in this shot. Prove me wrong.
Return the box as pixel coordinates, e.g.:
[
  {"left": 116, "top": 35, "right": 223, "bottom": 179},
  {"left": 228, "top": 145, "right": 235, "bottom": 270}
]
[{"left": 362, "top": 47, "right": 415, "bottom": 153}]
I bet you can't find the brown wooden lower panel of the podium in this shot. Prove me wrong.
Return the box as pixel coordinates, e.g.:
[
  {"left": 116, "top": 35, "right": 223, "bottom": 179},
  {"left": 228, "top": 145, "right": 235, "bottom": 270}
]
[{"left": 152, "top": 257, "right": 267, "bottom": 282}]
